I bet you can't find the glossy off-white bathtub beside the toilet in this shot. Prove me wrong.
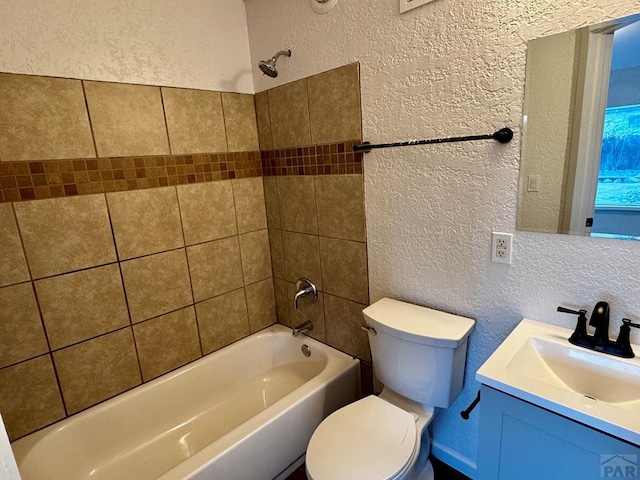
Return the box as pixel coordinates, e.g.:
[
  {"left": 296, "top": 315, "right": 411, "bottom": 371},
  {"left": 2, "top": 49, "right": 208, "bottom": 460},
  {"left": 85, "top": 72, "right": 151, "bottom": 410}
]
[{"left": 12, "top": 325, "right": 360, "bottom": 480}]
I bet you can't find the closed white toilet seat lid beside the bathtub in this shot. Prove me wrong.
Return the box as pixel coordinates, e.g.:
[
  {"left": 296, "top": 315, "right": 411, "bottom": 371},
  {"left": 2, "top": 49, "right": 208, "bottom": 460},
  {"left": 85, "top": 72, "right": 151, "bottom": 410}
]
[{"left": 306, "top": 395, "right": 419, "bottom": 480}]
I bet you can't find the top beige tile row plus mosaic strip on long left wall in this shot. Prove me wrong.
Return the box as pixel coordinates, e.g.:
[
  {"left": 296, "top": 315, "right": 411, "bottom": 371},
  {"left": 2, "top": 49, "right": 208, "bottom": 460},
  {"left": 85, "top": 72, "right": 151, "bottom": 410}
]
[{"left": 0, "top": 73, "right": 261, "bottom": 202}]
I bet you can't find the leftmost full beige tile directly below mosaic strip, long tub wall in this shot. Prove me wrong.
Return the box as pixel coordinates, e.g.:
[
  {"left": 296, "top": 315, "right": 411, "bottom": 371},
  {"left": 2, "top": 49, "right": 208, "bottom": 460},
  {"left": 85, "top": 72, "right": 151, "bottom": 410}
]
[{"left": 14, "top": 195, "right": 116, "bottom": 278}]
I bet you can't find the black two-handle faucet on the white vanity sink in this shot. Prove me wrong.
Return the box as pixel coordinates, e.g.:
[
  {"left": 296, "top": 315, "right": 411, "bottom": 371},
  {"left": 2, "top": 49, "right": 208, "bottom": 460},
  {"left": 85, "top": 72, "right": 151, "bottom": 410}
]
[{"left": 558, "top": 302, "right": 640, "bottom": 358}]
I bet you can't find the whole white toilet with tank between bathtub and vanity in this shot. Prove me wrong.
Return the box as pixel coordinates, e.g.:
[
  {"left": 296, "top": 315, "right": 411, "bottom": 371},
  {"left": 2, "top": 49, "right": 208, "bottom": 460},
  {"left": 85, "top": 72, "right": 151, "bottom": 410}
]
[{"left": 306, "top": 298, "right": 475, "bottom": 480}]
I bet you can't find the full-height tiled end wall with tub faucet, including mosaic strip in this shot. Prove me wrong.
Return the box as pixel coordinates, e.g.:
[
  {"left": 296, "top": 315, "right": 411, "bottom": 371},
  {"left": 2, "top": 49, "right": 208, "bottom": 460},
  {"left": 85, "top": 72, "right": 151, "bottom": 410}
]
[{"left": 255, "top": 63, "right": 372, "bottom": 392}]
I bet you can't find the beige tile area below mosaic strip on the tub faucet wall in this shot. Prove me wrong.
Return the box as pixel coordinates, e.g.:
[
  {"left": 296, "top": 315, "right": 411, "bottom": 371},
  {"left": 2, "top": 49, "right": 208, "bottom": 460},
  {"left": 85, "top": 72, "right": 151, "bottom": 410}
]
[{"left": 264, "top": 175, "right": 371, "bottom": 363}]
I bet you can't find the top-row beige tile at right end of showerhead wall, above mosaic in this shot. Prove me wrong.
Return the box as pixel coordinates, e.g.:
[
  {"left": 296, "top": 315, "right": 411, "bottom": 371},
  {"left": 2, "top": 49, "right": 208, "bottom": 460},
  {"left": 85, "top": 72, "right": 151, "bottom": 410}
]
[{"left": 307, "top": 63, "right": 362, "bottom": 145}]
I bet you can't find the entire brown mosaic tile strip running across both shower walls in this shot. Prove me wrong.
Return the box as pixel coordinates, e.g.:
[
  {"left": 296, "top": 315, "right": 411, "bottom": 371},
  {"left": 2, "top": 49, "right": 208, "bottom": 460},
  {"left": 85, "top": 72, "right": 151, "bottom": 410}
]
[{"left": 0, "top": 140, "right": 363, "bottom": 203}]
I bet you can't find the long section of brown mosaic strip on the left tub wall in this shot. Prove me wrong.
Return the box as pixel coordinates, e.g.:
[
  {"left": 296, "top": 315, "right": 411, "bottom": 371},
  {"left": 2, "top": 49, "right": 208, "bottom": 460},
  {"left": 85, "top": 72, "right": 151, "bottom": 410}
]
[{"left": 0, "top": 151, "right": 262, "bottom": 202}]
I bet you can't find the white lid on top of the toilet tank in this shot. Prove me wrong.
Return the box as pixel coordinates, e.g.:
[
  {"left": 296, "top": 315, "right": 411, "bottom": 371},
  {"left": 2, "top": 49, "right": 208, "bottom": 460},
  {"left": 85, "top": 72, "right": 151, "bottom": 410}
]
[{"left": 362, "top": 298, "right": 476, "bottom": 348}]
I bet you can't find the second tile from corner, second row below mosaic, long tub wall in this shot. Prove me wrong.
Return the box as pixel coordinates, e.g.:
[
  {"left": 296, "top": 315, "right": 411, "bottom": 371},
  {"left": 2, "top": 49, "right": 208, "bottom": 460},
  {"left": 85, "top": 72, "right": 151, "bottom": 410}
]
[{"left": 187, "top": 237, "right": 244, "bottom": 302}]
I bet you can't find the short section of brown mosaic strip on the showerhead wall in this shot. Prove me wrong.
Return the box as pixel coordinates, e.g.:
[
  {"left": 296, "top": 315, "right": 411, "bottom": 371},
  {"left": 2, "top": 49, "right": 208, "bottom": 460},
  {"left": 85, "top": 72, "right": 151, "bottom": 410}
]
[{"left": 260, "top": 140, "right": 363, "bottom": 177}]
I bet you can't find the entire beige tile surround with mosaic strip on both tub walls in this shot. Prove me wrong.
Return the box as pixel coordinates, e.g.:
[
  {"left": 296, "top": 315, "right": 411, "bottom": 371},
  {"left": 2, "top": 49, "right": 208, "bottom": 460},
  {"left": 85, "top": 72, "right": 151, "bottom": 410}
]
[{"left": 0, "top": 64, "right": 370, "bottom": 439}]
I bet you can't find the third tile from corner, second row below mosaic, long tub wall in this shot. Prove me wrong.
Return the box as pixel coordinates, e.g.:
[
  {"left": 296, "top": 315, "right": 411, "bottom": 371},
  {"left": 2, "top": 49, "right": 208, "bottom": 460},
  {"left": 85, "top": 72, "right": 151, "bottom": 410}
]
[{"left": 120, "top": 249, "right": 193, "bottom": 323}]
